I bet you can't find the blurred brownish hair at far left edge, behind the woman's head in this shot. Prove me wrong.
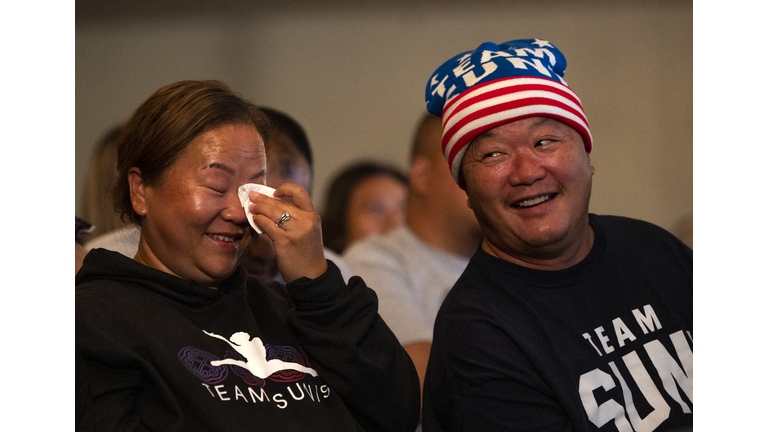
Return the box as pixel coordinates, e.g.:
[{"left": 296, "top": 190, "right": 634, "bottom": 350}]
[{"left": 80, "top": 125, "right": 124, "bottom": 237}]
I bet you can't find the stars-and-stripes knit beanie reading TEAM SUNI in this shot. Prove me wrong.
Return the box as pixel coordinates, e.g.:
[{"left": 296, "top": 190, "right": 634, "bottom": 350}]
[{"left": 425, "top": 39, "right": 592, "bottom": 188}]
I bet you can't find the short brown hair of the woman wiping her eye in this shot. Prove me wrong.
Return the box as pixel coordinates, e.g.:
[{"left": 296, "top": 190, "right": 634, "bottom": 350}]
[{"left": 113, "top": 80, "right": 272, "bottom": 225}]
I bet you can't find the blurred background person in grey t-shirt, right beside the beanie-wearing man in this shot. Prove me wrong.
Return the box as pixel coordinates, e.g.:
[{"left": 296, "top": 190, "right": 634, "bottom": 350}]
[{"left": 344, "top": 113, "right": 483, "bottom": 426}]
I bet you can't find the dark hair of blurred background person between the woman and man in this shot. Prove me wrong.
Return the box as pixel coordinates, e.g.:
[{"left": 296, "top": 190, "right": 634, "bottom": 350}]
[{"left": 322, "top": 161, "right": 408, "bottom": 254}]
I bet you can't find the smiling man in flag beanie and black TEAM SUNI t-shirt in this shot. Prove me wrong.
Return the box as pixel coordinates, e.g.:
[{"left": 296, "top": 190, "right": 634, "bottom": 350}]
[{"left": 423, "top": 39, "right": 693, "bottom": 432}]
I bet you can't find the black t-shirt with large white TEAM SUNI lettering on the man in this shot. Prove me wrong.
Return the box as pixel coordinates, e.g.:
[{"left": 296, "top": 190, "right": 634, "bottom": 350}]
[{"left": 424, "top": 215, "right": 693, "bottom": 432}]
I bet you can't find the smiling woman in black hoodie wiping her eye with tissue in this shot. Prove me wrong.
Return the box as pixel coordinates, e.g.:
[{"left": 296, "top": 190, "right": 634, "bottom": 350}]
[{"left": 76, "top": 81, "right": 419, "bottom": 431}]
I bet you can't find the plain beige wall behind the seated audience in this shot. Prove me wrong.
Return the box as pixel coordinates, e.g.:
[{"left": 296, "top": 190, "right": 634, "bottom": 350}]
[{"left": 75, "top": 0, "right": 693, "bottom": 233}]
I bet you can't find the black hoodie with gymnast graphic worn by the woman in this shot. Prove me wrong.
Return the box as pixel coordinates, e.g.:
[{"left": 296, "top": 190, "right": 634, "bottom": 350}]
[{"left": 75, "top": 249, "right": 419, "bottom": 432}]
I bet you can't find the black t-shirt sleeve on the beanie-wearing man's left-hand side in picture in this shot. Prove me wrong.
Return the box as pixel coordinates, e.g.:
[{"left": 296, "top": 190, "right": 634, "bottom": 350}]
[{"left": 424, "top": 294, "right": 572, "bottom": 431}]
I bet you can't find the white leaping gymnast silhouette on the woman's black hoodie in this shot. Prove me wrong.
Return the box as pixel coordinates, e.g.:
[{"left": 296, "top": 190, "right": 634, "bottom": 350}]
[{"left": 203, "top": 330, "right": 317, "bottom": 379}]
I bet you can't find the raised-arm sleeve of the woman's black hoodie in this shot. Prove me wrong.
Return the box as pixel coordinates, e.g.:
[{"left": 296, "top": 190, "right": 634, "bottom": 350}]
[{"left": 287, "top": 262, "right": 420, "bottom": 432}]
